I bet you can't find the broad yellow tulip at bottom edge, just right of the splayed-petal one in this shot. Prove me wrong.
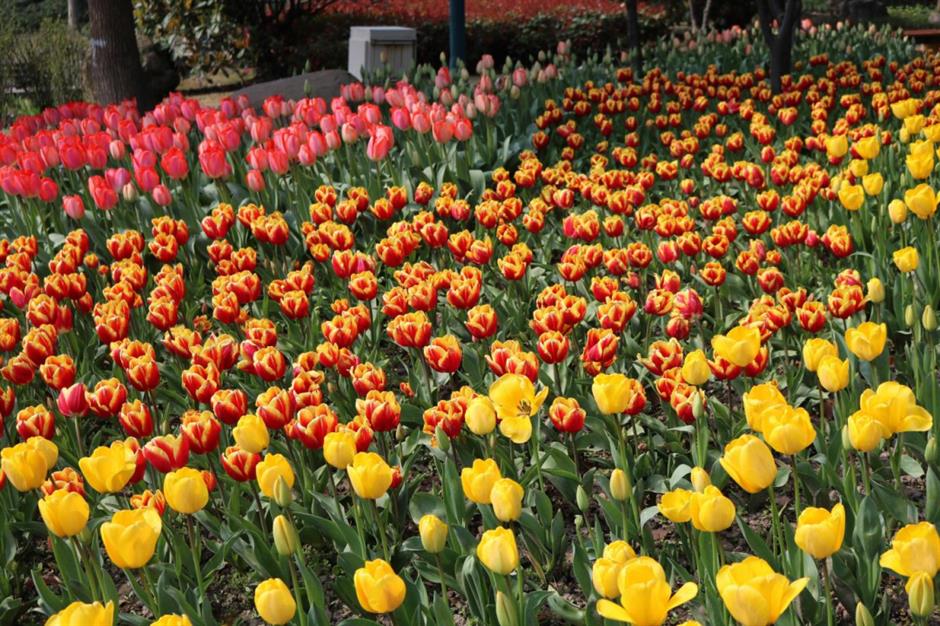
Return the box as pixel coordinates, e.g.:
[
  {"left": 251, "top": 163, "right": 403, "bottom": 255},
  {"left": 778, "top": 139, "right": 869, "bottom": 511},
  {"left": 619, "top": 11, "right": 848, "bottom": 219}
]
[{"left": 715, "top": 556, "right": 809, "bottom": 626}]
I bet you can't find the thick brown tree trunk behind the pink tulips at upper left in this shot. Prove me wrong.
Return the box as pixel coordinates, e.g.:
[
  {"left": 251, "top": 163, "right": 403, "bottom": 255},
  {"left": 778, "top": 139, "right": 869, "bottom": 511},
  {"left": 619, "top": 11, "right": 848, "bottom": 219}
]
[{"left": 88, "top": 0, "right": 151, "bottom": 110}]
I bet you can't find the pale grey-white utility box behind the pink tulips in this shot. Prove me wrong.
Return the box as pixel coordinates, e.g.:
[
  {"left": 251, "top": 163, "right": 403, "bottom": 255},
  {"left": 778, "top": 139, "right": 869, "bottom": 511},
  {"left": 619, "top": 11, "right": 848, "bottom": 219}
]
[{"left": 348, "top": 26, "right": 418, "bottom": 79}]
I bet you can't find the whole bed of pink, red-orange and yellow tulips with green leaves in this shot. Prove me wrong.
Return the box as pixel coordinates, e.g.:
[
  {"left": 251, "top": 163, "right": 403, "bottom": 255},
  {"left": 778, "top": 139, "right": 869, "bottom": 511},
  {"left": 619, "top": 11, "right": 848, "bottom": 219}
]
[{"left": 0, "top": 22, "right": 940, "bottom": 626}]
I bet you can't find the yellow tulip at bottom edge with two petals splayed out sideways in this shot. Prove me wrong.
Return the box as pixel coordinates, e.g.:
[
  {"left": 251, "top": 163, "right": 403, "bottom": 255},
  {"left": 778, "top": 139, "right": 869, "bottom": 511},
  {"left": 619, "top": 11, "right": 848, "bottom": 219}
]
[{"left": 597, "top": 556, "right": 698, "bottom": 626}]
